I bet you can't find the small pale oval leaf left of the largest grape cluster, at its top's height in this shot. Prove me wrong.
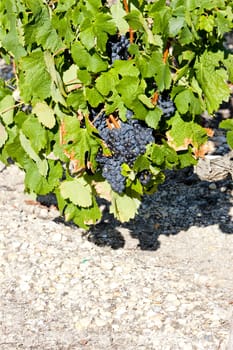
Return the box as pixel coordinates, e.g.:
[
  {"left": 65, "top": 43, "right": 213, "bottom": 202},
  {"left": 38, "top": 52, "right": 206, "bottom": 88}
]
[{"left": 32, "top": 102, "right": 56, "bottom": 129}]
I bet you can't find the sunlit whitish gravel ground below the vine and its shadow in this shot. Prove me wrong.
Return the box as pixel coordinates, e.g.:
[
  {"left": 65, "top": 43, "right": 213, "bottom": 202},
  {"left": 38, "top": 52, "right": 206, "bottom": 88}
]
[{"left": 0, "top": 166, "right": 233, "bottom": 350}]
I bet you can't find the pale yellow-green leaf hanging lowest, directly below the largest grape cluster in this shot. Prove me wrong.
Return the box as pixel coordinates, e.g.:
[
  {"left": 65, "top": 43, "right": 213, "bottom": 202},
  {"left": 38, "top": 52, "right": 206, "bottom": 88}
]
[{"left": 110, "top": 192, "right": 141, "bottom": 222}]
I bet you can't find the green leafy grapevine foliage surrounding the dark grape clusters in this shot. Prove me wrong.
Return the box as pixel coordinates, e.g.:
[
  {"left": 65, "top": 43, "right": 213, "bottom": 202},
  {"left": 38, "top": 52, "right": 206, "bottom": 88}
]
[{"left": 0, "top": 0, "right": 233, "bottom": 228}]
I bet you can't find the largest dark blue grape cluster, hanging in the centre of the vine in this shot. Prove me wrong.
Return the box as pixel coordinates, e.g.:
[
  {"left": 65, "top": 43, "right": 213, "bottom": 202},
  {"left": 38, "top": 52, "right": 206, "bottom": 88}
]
[{"left": 93, "top": 110, "right": 154, "bottom": 193}]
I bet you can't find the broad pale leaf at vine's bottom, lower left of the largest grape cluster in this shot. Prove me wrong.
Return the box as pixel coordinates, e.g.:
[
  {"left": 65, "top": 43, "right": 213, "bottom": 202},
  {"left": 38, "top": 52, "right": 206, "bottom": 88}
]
[{"left": 60, "top": 178, "right": 92, "bottom": 208}]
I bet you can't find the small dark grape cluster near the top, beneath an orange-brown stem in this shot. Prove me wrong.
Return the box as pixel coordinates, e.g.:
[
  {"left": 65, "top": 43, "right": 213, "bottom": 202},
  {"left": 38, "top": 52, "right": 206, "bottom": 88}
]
[{"left": 107, "top": 35, "right": 129, "bottom": 63}]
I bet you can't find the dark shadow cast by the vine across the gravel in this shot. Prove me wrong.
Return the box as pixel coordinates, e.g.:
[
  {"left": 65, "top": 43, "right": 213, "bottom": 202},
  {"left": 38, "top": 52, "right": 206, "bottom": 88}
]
[{"left": 87, "top": 169, "right": 233, "bottom": 250}]
